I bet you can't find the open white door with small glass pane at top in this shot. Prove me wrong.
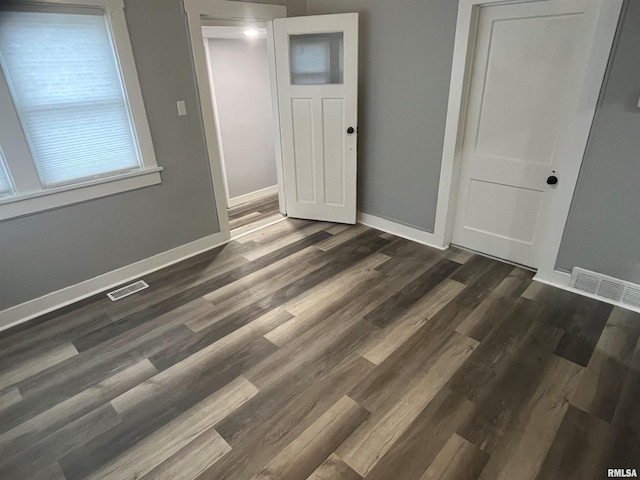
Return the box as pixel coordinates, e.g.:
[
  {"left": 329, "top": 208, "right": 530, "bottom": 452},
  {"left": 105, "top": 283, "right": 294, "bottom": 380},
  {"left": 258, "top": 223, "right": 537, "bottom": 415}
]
[{"left": 273, "top": 13, "right": 358, "bottom": 223}]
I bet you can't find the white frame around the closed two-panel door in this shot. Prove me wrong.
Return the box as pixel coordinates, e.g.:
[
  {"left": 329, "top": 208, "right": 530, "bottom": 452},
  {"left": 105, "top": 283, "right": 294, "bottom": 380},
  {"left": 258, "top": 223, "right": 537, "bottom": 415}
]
[{"left": 433, "top": 0, "right": 623, "bottom": 285}]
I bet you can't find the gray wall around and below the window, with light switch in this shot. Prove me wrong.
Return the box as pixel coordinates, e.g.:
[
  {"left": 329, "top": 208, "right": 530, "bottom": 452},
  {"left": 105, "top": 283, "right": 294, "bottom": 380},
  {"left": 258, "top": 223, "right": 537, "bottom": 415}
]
[{"left": 0, "top": 0, "right": 219, "bottom": 310}]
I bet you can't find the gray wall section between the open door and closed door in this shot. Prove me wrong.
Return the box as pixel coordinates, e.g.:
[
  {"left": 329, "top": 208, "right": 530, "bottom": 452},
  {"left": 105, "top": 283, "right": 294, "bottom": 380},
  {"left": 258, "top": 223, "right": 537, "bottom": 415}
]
[{"left": 307, "top": 0, "right": 458, "bottom": 232}]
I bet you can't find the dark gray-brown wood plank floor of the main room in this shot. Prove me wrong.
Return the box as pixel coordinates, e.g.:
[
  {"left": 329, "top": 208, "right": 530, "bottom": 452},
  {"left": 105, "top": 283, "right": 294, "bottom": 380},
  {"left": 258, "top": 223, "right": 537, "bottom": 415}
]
[{"left": 0, "top": 220, "right": 640, "bottom": 480}]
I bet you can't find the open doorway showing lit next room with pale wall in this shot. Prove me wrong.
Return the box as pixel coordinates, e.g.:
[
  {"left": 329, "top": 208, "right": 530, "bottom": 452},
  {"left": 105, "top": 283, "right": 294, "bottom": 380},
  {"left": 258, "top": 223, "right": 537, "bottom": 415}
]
[{"left": 202, "top": 19, "right": 285, "bottom": 238}]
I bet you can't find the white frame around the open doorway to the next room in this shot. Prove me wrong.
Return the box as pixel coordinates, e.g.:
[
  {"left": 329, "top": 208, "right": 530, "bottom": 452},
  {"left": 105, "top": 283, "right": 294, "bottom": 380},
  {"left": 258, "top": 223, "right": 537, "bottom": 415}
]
[{"left": 183, "top": 0, "right": 287, "bottom": 241}]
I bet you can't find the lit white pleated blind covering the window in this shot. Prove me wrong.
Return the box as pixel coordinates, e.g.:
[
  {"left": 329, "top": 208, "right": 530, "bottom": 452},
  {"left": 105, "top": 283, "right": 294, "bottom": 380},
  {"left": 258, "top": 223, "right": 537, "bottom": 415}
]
[{"left": 0, "top": 12, "right": 141, "bottom": 189}]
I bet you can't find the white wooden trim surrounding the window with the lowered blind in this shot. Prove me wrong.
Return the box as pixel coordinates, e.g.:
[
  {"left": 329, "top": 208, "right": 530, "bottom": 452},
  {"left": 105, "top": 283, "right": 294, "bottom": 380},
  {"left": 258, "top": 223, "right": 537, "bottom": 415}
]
[{"left": 0, "top": 0, "right": 162, "bottom": 221}]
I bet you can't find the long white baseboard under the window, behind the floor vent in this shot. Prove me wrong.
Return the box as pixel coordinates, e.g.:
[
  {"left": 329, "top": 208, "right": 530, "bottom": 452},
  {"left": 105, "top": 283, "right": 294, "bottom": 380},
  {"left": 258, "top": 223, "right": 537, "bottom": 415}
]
[{"left": 0, "top": 233, "right": 228, "bottom": 331}]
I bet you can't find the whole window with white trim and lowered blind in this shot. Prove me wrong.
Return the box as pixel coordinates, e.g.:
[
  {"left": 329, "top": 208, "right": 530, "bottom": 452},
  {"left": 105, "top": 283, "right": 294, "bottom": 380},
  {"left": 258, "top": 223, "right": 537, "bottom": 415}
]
[{"left": 0, "top": 0, "right": 160, "bottom": 219}]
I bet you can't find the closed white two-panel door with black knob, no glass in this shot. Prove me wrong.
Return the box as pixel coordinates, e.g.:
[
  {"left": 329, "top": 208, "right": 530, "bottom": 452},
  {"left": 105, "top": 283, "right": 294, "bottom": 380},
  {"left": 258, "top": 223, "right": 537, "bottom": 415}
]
[{"left": 453, "top": 0, "right": 599, "bottom": 267}]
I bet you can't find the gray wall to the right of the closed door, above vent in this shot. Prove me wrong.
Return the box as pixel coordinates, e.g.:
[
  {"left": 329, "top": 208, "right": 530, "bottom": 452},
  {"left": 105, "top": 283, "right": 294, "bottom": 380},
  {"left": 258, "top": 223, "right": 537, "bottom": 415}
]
[{"left": 557, "top": 0, "right": 640, "bottom": 283}]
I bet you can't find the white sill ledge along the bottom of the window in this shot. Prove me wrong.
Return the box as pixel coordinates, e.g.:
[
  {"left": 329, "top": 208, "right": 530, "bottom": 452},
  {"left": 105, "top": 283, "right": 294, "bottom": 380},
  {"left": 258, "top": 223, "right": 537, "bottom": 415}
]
[{"left": 0, "top": 167, "right": 162, "bottom": 221}]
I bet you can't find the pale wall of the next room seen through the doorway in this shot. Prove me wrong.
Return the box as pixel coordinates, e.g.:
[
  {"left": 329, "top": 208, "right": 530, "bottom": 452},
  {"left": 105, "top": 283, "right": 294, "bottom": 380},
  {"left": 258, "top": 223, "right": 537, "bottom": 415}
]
[{"left": 209, "top": 39, "right": 278, "bottom": 199}]
